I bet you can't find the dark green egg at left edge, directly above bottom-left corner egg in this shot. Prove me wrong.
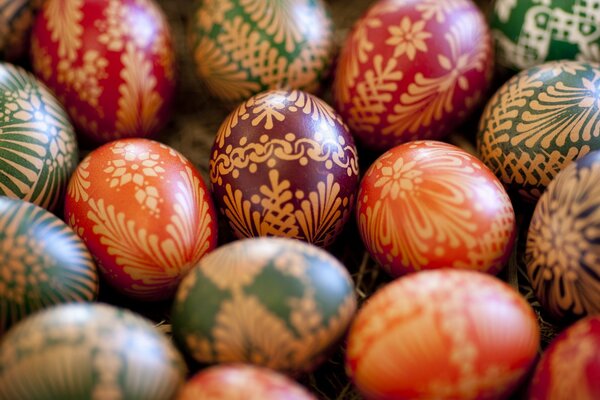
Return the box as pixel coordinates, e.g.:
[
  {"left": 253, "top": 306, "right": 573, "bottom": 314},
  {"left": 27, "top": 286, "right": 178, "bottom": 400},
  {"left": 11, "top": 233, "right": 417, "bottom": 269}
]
[{"left": 0, "top": 196, "right": 98, "bottom": 334}]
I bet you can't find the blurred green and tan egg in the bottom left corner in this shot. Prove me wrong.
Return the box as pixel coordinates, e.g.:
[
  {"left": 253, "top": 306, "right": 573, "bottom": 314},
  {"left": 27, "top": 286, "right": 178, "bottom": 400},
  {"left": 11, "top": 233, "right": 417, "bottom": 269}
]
[{"left": 0, "top": 304, "right": 185, "bottom": 400}]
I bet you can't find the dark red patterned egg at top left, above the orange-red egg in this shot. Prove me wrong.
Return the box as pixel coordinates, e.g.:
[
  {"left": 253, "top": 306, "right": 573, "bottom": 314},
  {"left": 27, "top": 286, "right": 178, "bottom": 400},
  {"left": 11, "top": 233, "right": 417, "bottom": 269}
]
[{"left": 31, "top": 0, "right": 175, "bottom": 143}]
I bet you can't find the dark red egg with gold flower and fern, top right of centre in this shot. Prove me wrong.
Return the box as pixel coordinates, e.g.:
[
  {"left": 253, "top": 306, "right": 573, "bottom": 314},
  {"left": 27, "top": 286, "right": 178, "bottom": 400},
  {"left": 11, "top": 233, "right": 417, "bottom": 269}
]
[{"left": 334, "top": 0, "right": 493, "bottom": 151}]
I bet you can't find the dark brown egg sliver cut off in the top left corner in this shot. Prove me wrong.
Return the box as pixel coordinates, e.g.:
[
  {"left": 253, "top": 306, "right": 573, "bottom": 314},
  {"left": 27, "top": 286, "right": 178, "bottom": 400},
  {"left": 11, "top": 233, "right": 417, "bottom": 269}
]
[{"left": 0, "top": 0, "right": 41, "bottom": 61}]
